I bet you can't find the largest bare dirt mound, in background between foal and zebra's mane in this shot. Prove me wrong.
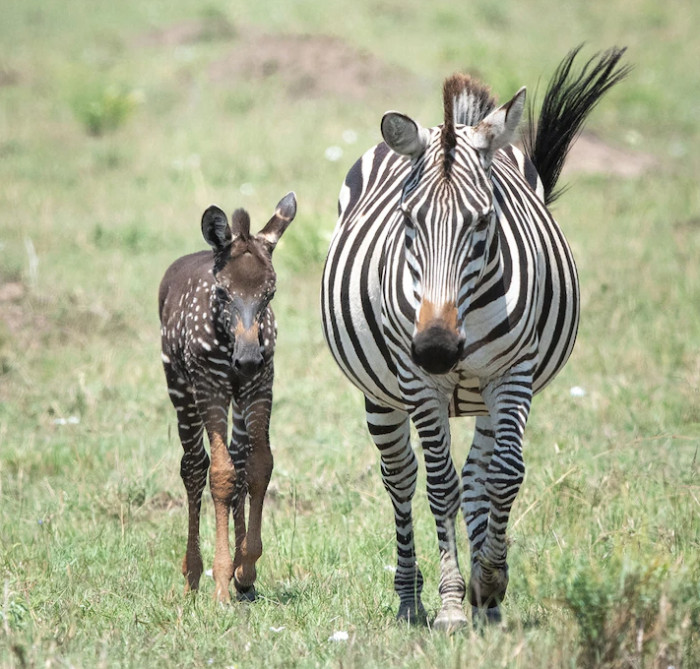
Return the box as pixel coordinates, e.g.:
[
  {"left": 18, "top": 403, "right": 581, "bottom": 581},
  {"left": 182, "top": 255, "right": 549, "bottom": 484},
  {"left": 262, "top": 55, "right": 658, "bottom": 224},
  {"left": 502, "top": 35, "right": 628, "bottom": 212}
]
[{"left": 209, "top": 34, "right": 414, "bottom": 100}]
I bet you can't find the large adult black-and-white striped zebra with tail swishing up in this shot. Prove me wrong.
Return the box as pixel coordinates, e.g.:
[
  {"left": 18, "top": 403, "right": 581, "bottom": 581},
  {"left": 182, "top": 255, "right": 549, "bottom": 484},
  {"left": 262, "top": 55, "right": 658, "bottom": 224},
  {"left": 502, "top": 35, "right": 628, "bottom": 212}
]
[{"left": 321, "top": 47, "right": 629, "bottom": 629}]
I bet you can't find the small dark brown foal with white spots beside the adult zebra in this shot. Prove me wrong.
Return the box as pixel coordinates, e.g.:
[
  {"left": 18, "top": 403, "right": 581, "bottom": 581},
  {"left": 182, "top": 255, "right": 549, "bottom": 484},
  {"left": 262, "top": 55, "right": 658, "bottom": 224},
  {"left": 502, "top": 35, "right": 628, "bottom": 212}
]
[{"left": 159, "top": 193, "right": 296, "bottom": 602}]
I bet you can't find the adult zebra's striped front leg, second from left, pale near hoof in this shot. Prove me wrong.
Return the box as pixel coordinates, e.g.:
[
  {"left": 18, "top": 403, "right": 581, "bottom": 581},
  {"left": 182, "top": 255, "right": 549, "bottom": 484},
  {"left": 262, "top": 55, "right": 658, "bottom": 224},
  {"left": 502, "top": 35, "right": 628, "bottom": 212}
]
[{"left": 411, "top": 402, "right": 467, "bottom": 631}]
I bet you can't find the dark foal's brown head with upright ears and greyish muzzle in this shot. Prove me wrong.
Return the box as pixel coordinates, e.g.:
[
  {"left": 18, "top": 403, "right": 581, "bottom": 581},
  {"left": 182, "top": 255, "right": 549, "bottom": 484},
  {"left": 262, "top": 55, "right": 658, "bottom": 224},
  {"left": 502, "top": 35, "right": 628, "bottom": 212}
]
[{"left": 202, "top": 193, "right": 297, "bottom": 377}]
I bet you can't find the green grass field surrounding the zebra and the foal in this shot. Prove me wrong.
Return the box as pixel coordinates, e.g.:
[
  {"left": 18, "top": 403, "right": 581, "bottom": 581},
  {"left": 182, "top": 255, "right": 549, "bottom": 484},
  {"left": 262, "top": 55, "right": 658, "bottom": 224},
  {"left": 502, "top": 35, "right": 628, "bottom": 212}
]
[{"left": 0, "top": 0, "right": 700, "bottom": 669}]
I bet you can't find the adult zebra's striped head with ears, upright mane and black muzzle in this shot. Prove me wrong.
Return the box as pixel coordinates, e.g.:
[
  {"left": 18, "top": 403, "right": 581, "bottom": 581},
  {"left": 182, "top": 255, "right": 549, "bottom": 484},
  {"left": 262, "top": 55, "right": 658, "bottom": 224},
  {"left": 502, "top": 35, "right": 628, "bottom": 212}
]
[{"left": 381, "top": 75, "right": 525, "bottom": 374}]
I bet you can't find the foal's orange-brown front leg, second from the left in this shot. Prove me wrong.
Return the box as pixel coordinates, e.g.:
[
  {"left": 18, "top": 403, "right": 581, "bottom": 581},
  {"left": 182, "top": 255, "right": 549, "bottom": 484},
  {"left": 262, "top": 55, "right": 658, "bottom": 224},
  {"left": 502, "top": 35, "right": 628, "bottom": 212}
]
[{"left": 198, "top": 396, "right": 236, "bottom": 603}]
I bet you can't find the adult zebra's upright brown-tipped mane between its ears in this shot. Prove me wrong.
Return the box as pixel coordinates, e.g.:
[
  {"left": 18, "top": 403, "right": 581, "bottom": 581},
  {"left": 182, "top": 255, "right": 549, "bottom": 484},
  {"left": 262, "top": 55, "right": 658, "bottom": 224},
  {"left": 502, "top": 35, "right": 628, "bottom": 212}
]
[{"left": 440, "top": 73, "right": 496, "bottom": 177}]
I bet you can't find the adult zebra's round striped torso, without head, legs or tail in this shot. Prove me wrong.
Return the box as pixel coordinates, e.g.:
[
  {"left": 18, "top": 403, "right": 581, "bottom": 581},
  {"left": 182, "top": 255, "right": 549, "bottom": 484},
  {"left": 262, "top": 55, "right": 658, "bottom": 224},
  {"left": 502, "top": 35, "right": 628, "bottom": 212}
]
[{"left": 323, "top": 141, "right": 578, "bottom": 416}]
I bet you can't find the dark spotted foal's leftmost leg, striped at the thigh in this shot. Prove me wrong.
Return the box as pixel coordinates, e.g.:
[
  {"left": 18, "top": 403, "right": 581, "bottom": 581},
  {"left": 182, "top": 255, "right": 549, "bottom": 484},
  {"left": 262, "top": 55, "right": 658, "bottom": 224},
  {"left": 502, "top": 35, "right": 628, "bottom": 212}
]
[{"left": 165, "top": 364, "right": 209, "bottom": 592}]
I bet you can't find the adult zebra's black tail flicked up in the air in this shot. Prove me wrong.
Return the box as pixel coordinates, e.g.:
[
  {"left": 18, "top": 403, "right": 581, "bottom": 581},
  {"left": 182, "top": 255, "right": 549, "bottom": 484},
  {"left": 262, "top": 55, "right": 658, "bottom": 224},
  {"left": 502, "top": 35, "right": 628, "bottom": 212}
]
[{"left": 523, "top": 44, "right": 632, "bottom": 204}]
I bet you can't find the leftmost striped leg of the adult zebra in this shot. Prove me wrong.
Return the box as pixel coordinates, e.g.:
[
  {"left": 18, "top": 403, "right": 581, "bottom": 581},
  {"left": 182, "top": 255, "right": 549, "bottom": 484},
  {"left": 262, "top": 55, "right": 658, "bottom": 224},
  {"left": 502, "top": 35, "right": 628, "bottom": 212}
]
[{"left": 365, "top": 398, "right": 425, "bottom": 623}]
